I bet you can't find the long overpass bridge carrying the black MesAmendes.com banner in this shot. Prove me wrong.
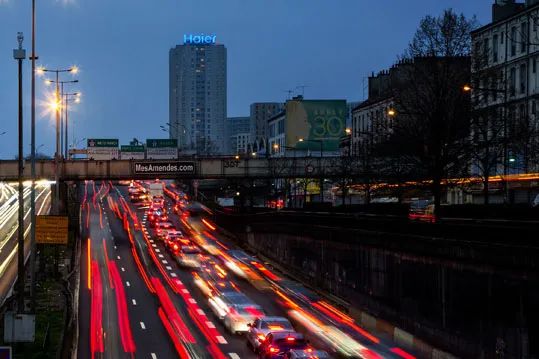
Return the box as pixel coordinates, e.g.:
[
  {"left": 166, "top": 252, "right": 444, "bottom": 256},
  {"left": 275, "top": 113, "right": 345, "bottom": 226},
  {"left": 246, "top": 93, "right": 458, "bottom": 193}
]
[{"left": 0, "top": 157, "right": 361, "bottom": 182}]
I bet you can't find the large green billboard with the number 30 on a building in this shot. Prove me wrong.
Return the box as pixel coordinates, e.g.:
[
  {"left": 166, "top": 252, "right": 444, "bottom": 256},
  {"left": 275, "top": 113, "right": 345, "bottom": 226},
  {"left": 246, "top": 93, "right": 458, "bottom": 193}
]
[{"left": 285, "top": 99, "right": 347, "bottom": 152}]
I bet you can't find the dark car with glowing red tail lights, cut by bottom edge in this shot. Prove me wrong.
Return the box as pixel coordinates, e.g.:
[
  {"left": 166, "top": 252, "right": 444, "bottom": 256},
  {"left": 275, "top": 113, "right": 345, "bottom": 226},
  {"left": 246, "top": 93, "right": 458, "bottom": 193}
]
[{"left": 258, "top": 331, "right": 313, "bottom": 359}]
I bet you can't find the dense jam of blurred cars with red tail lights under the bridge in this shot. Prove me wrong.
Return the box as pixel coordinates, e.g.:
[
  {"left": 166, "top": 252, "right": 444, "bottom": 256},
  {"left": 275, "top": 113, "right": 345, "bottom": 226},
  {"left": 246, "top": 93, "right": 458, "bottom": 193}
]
[{"left": 127, "top": 180, "right": 414, "bottom": 359}]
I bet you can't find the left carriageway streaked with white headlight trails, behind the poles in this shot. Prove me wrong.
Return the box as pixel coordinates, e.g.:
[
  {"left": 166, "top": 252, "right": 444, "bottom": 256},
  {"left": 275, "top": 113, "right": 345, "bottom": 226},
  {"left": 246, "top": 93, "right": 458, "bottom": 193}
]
[{"left": 0, "top": 182, "right": 51, "bottom": 303}]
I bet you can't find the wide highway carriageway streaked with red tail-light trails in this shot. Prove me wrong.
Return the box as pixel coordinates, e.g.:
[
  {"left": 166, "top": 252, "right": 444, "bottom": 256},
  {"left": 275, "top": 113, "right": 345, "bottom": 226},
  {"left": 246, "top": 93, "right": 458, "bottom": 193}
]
[{"left": 78, "top": 181, "right": 415, "bottom": 359}]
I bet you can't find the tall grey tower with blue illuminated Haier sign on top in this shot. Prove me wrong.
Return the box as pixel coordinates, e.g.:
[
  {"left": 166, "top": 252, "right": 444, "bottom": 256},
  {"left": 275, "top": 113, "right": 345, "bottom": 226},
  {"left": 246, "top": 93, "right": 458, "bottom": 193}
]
[{"left": 168, "top": 34, "right": 227, "bottom": 156}]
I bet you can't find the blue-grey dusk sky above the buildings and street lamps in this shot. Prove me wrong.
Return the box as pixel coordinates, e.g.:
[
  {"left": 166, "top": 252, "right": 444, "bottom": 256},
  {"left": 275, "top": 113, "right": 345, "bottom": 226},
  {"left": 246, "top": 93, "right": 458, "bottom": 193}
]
[{"left": 0, "top": 0, "right": 493, "bottom": 159}]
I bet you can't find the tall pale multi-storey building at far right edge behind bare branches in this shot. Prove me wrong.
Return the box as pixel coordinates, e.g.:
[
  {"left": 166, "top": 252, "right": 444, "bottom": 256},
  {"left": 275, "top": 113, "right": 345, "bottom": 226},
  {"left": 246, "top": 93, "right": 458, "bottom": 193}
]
[{"left": 471, "top": 0, "right": 539, "bottom": 175}]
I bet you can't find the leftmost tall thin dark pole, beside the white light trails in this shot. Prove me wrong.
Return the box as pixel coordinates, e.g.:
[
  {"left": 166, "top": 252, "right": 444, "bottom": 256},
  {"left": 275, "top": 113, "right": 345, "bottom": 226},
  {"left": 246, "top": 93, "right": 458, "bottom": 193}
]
[{"left": 13, "top": 32, "right": 26, "bottom": 313}]
